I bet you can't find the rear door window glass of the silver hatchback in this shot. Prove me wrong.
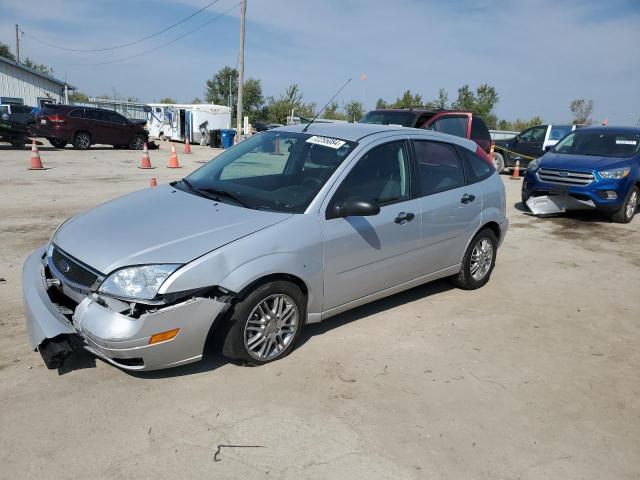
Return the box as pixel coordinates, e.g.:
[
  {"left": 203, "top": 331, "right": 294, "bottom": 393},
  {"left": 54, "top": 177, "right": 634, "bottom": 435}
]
[{"left": 413, "top": 140, "right": 465, "bottom": 195}]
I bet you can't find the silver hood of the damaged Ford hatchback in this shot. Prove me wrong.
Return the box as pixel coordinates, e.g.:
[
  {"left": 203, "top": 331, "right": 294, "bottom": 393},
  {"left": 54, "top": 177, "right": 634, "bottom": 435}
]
[{"left": 52, "top": 185, "right": 291, "bottom": 274}]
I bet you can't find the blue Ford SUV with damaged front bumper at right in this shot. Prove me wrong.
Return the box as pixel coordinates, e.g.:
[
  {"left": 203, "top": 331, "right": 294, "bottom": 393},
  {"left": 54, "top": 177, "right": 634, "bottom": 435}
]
[{"left": 522, "top": 127, "right": 640, "bottom": 223}]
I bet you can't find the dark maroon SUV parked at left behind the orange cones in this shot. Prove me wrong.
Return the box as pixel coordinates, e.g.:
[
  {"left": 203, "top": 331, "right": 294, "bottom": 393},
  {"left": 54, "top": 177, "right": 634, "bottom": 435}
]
[{"left": 29, "top": 105, "right": 149, "bottom": 150}]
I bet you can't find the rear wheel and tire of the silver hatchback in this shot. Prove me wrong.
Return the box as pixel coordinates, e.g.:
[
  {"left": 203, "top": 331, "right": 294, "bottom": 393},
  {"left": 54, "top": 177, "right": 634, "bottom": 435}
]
[{"left": 451, "top": 228, "right": 498, "bottom": 290}]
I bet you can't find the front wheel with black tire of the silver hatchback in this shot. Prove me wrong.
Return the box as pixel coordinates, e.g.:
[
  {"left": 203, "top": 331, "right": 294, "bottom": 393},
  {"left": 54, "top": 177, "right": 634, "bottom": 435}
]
[{"left": 222, "top": 281, "right": 307, "bottom": 366}]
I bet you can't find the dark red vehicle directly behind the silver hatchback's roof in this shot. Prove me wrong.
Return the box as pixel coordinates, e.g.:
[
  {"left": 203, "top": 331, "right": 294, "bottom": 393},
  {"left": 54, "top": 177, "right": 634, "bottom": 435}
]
[{"left": 360, "top": 108, "right": 492, "bottom": 161}]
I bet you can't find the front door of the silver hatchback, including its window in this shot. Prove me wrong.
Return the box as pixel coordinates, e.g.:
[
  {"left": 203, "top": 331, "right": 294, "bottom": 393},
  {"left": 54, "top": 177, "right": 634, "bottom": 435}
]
[{"left": 322, "top": 140, "right": 420, "bottom": 310}]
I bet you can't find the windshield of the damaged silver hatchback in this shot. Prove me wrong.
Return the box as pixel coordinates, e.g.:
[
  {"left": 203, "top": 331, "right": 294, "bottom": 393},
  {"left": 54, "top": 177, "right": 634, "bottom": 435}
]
[{"left": 182, "top": 131, "right": 356, "bottom": 213}]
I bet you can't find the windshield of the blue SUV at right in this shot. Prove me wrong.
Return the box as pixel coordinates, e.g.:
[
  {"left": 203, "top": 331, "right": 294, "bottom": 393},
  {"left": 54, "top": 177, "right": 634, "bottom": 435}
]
[{"left": 553, "top": 130, "right": 640, "bottom": 157}]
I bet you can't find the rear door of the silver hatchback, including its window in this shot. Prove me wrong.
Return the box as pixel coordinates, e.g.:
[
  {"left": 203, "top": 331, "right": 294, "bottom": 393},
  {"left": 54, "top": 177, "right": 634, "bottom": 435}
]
[{"left": 412, "top": 139, "right": 480, "bottom": 274}]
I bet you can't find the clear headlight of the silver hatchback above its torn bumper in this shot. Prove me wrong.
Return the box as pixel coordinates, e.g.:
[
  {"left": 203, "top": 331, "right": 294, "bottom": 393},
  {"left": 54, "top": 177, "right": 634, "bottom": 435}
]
[{"left": 98, "top": 264, "right": 180, "bottom": 300}]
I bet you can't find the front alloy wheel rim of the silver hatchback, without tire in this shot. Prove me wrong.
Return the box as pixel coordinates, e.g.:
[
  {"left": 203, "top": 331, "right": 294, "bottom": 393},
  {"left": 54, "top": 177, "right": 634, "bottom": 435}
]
[{"left": 244, "top": 294, "right": 299, "bottom": 361}]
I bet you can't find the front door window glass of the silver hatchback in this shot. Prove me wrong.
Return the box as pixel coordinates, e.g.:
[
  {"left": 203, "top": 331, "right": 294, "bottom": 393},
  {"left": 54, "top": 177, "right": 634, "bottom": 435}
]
[{"left": 331, "top": 140, "right": 411, "bottom": 205}]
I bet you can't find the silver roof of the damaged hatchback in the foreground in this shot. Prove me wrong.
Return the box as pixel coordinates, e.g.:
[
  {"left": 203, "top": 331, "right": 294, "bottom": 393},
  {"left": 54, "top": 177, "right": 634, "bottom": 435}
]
[{"left": 270, "top": 123, "right": 477, "bottom": 152}]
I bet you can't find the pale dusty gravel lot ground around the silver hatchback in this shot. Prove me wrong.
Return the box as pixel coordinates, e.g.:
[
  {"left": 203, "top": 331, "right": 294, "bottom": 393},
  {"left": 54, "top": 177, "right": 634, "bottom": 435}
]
[{"left": 0, "top": 142, "right": 640, "bottom": 480}]
